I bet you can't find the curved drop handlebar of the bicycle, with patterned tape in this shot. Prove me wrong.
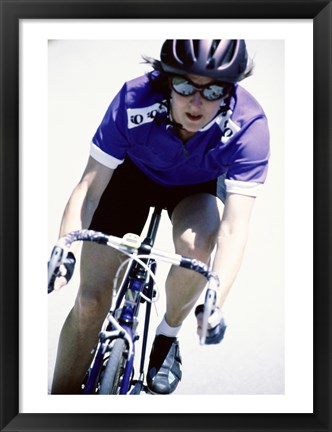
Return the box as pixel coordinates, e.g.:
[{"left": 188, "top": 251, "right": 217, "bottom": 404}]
[{"left": 48, "top": 229, "right": 219, "bottom": 345}]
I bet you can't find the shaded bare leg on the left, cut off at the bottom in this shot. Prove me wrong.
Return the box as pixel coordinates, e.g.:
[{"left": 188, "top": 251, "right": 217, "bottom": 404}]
[{"left": 52, "top": 243, "right": 124, "bottom": 394}]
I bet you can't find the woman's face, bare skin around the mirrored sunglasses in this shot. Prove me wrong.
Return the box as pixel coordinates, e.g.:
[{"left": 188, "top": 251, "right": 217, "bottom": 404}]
[{"left": 171, "top": 75, "right": 221, "bottom": 140}]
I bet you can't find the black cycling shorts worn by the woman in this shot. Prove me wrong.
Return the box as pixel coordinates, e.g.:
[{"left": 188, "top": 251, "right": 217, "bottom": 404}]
[{"left": 90, "top": 158, "right": 226, "bottom": 237}]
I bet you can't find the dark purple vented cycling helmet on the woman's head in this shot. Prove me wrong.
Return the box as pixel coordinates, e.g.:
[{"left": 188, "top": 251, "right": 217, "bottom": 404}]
[{"left": 160, "top": 39, "right": 248, "bottom": 83}]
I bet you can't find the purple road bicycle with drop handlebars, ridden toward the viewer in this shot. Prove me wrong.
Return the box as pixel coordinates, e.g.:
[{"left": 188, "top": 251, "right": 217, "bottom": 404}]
[{"left": 48, "top": 207, "right": 219, "bottom": 395}]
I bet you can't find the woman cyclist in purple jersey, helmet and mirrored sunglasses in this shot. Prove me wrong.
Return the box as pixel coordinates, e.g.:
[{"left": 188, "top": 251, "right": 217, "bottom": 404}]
[{"left": 52, "top": 40, "right": 269, "bottom": 394}]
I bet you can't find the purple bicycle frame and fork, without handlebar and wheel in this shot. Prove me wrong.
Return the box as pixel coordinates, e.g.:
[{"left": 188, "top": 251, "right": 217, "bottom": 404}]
[{"left": 84, "top": 208, "right": 162, "bottom": 394}]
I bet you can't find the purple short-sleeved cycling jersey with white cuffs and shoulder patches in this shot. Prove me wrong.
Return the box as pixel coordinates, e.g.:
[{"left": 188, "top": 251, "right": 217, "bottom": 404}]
[{"left": 90, "top": 71, "right": 269, "bottom": 196}]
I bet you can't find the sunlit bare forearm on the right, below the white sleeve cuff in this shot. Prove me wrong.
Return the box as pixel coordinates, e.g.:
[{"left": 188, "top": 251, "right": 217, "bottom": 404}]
[{"left": 213, "top": 194, "right": 255, "bottom": 307}]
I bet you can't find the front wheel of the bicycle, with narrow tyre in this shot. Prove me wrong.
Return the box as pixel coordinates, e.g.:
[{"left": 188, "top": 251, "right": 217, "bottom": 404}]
[{"left": 99, "top": 339, "right": 127, "bottom": 394}]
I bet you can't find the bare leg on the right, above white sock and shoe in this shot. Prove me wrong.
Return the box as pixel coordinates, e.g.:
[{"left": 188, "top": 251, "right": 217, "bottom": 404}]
[{"left": 165, "top": 194, "right": 223, "bottom": 327}]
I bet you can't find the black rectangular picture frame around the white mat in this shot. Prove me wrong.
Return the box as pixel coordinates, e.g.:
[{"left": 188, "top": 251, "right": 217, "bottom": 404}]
[{"left": 0, "top": 0, "right": 332, "bottom": 432}]
